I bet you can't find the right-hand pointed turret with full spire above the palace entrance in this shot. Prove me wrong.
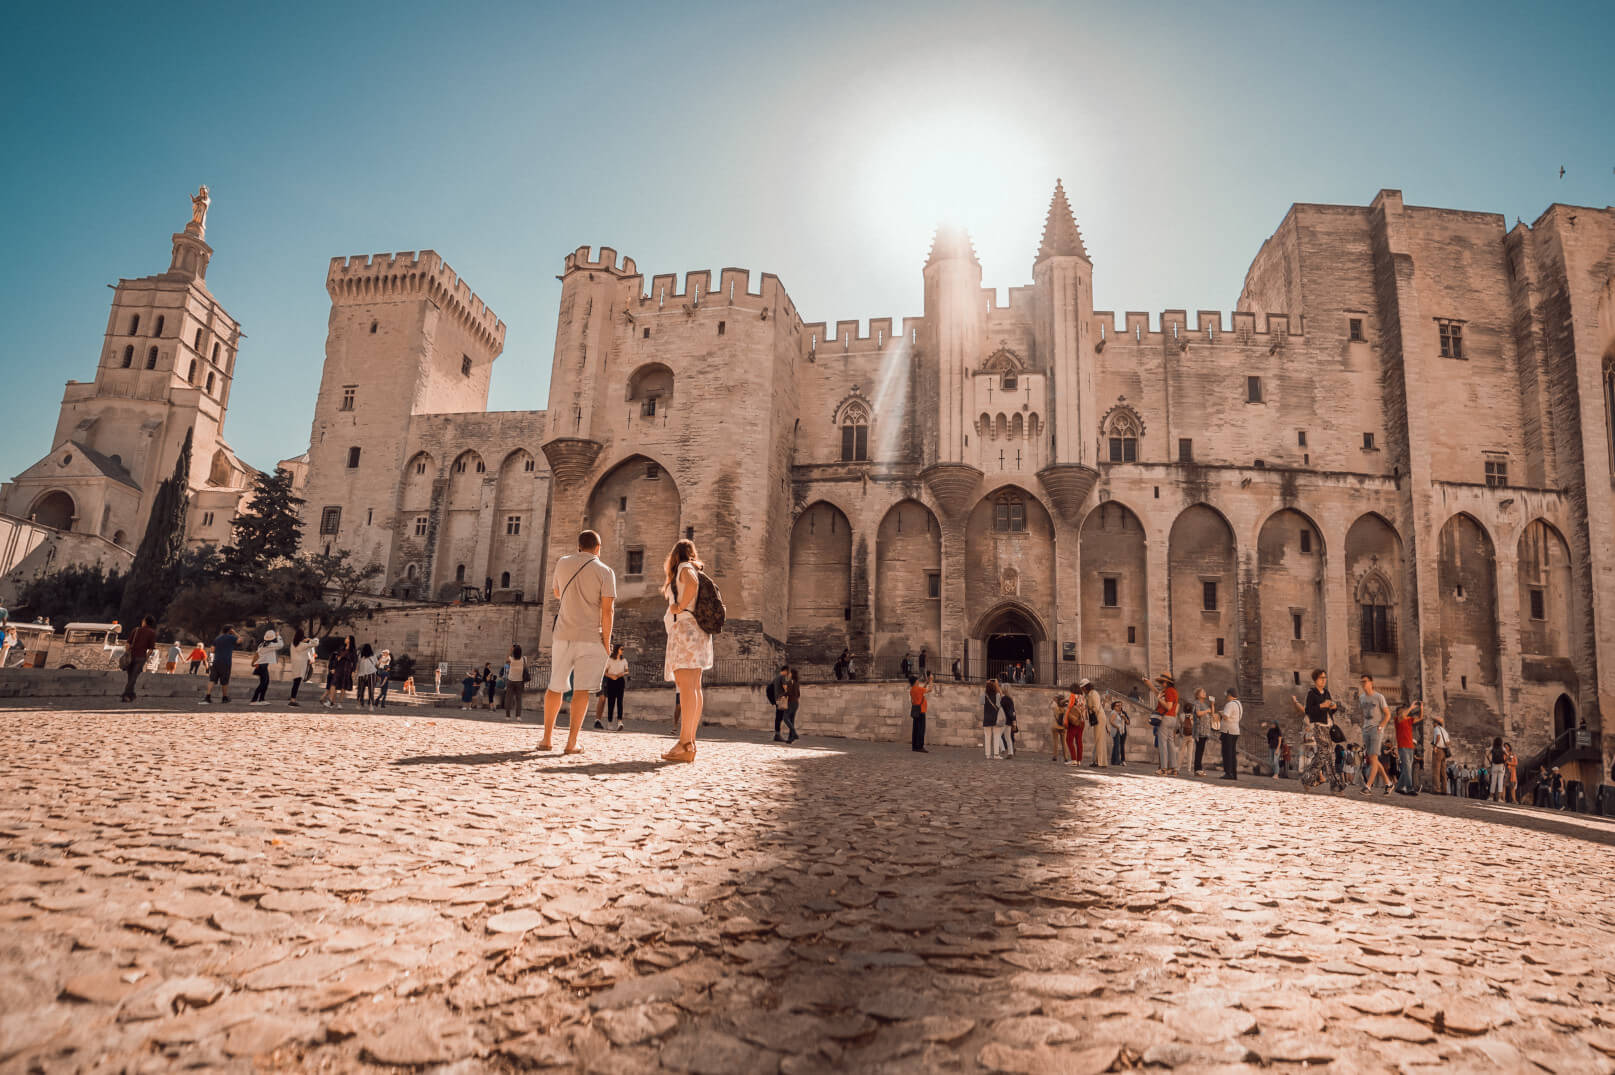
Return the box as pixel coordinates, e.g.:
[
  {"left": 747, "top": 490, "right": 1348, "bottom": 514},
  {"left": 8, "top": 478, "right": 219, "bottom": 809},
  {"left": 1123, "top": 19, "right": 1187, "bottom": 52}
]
[{"left": 1032, "top": 179, "right": 1098, "bottom": 520}]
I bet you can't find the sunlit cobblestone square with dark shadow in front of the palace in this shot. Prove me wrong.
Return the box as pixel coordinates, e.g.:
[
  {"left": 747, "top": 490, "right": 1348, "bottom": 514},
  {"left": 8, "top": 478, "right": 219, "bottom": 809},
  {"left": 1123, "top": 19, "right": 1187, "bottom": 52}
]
[{"left": 0, "top": 709, "right": 1615, "bottom": 1075}]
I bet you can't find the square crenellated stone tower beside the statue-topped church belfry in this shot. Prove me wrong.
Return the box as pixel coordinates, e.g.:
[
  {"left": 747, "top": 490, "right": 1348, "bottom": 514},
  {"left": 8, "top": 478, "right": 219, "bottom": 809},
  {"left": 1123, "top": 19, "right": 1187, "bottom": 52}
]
[{"left": 304, "top": 250, "right": 505, "bottom": 584}]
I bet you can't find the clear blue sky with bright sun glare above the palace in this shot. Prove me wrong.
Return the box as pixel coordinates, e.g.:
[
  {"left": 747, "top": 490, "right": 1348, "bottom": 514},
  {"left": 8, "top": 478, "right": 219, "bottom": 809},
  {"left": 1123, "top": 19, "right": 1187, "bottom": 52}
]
[{"left": 0, "top": 0, "right": 1615, "bottom": 476}]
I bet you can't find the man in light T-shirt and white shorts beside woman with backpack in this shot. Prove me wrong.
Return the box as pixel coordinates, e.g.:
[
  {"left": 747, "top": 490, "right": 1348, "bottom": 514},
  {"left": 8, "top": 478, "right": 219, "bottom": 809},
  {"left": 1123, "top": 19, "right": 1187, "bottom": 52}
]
[{"left": 538, "top": 529, "right": 617, "bottom": 754}]
